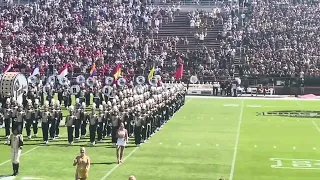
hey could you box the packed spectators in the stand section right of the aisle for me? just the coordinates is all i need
[240,1,320,77]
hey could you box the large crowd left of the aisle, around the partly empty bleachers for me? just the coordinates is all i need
[0,0,240,82]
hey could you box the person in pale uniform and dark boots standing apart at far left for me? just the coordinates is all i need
[9,128,23,176]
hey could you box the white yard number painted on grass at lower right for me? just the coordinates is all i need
[270,158,320,170]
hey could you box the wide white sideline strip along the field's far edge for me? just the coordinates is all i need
[187,95,320,100]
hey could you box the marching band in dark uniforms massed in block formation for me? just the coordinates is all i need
[2,81,185,146]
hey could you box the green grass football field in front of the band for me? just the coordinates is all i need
[0,97,320,180]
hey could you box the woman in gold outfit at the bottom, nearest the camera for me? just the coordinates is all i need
[73,147,90,180]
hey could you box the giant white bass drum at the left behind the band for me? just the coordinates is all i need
[0,72,28,104]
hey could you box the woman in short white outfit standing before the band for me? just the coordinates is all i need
[117,122,129,164]
